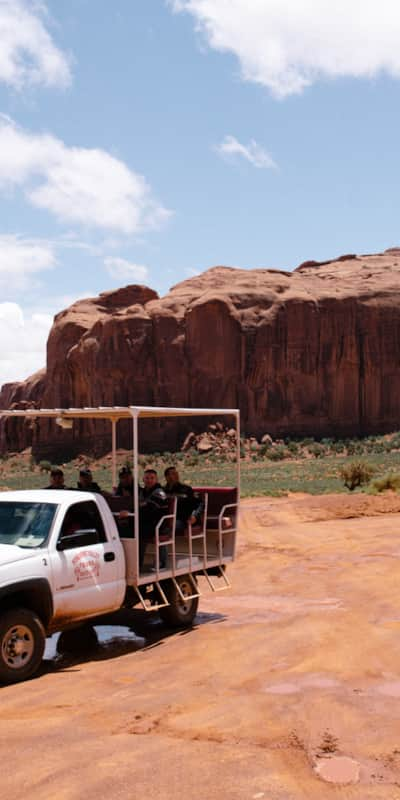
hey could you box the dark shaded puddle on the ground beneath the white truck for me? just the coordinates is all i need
[43,625,146,661]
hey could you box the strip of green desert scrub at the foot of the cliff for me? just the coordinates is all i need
[0,426,400,497]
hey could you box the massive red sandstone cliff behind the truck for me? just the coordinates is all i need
[0,255,400,456]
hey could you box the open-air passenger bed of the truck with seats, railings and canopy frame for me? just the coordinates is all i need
[0,406,240,610]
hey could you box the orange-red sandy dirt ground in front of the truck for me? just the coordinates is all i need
[0,495,400,800]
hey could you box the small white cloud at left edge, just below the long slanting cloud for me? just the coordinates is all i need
[0,235,56,290]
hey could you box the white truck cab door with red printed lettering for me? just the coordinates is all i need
[49,500,120,618]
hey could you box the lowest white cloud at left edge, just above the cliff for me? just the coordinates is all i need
[0,303,53,386]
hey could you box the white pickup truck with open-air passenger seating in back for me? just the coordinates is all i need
[0,408,238,683]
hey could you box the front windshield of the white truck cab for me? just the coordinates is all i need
[0,501,57,547]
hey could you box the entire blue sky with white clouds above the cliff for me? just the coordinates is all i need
[0,0,400,384]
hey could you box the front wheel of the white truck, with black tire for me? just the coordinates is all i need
[0,608,46,683]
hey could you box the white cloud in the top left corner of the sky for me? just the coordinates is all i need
[0,0,71,89]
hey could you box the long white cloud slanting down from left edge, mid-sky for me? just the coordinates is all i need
[0,115,170,234]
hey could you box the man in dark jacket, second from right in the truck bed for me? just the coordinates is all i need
[139,469,168,569]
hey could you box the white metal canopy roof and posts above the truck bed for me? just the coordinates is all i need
[0,406,240,556]
